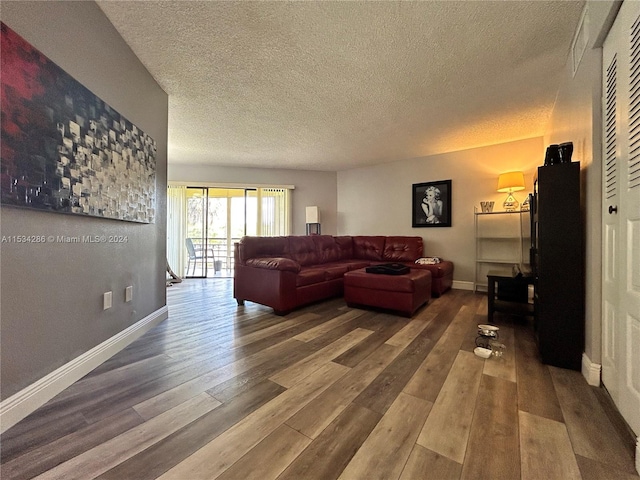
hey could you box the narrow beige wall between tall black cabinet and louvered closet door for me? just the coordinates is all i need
[544,1,619,364]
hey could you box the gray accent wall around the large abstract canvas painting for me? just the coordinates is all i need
[0,0,168,400]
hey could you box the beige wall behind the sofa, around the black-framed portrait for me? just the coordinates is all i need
[338,137,544,282]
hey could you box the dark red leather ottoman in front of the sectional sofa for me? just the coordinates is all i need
[343,268,431,317]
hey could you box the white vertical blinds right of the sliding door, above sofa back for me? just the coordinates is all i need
[258,188,291,237]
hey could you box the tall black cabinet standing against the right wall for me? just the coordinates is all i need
[531,162,585,370]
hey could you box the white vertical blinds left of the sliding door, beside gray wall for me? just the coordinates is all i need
[167,184,187,277]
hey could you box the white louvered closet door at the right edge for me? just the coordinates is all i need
[602,1,640,436]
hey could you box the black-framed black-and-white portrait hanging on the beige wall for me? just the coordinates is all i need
[411,180,451,228]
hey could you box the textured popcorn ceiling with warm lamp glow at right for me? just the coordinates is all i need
[98,0,584,170]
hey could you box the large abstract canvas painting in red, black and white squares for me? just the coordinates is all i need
[0,23,156,223]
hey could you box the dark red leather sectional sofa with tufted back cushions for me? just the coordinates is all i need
[233,235,453,315]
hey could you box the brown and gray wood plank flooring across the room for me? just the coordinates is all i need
[0,279,639,480]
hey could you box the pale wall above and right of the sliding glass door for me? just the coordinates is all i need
[168,164,337,235]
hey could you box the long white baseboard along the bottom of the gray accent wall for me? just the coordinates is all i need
[0,305,169,433]
